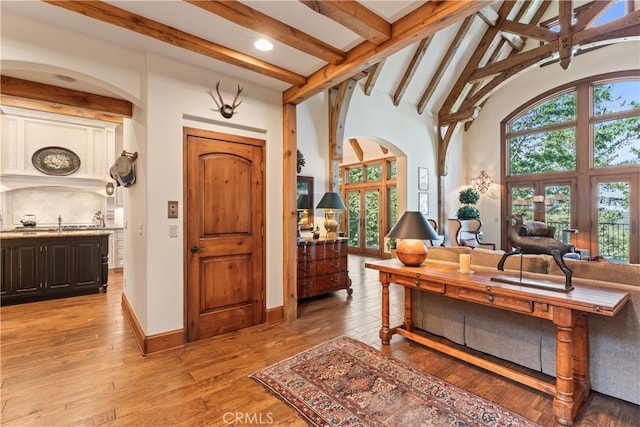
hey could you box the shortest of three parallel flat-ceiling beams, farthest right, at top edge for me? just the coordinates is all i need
[300,0,391,45]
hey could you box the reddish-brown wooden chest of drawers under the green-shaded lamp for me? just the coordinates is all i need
[297,239,353,299]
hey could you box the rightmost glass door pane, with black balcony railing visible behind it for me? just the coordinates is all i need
[591,175,640,263]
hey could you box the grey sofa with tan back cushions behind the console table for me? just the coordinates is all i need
[412,247,640,404]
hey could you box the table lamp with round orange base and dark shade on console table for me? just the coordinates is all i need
[387,211,439,267]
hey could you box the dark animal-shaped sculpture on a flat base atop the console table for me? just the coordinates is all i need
[494,215,575,292]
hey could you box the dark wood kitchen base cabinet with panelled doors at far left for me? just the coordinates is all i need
[0,233,109,305]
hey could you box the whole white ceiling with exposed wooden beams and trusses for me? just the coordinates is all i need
[1,0,640,155]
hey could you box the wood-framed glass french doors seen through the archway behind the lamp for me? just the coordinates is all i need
[346,187,382,257]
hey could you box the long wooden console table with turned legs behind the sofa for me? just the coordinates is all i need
[365,259,629,425]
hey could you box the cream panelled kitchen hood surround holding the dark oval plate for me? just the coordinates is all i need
[0,106,118,190]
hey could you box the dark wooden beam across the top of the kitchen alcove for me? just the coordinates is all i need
[0,76,133,119]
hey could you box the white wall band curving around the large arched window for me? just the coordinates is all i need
[464,42,640,249]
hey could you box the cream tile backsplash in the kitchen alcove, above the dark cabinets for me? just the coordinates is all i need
[0,187,106,230]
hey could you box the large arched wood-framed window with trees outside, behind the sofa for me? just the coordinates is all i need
[502,70,640,263]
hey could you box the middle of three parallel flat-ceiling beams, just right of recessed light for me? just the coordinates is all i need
[183,0,345,64]
